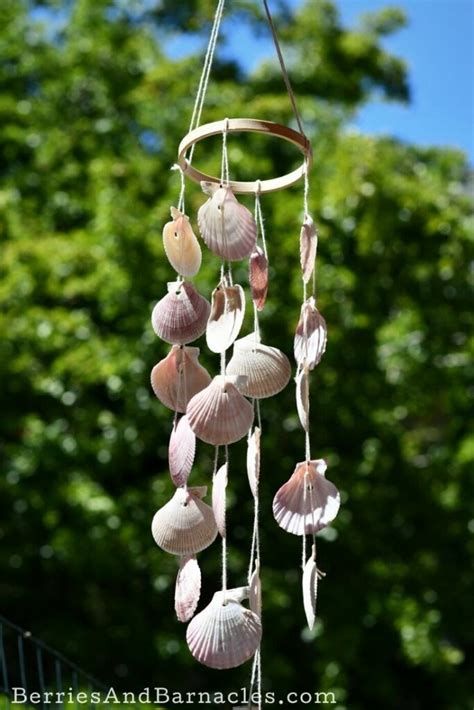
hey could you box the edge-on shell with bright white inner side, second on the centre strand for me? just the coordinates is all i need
[206,284,245,353]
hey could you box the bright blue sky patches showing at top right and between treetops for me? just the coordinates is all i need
[170,0,474,163]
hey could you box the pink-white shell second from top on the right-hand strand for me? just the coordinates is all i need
[294,296,327,370]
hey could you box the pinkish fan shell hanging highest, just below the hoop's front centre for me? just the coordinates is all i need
[198,183,257,261]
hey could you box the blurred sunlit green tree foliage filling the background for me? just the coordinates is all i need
[0,0,474,710]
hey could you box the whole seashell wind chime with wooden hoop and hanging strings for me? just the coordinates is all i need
[151,0,340,696]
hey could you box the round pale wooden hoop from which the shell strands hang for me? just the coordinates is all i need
[178,118,313,195]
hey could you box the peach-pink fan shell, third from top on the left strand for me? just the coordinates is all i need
[151,345,211,412]
